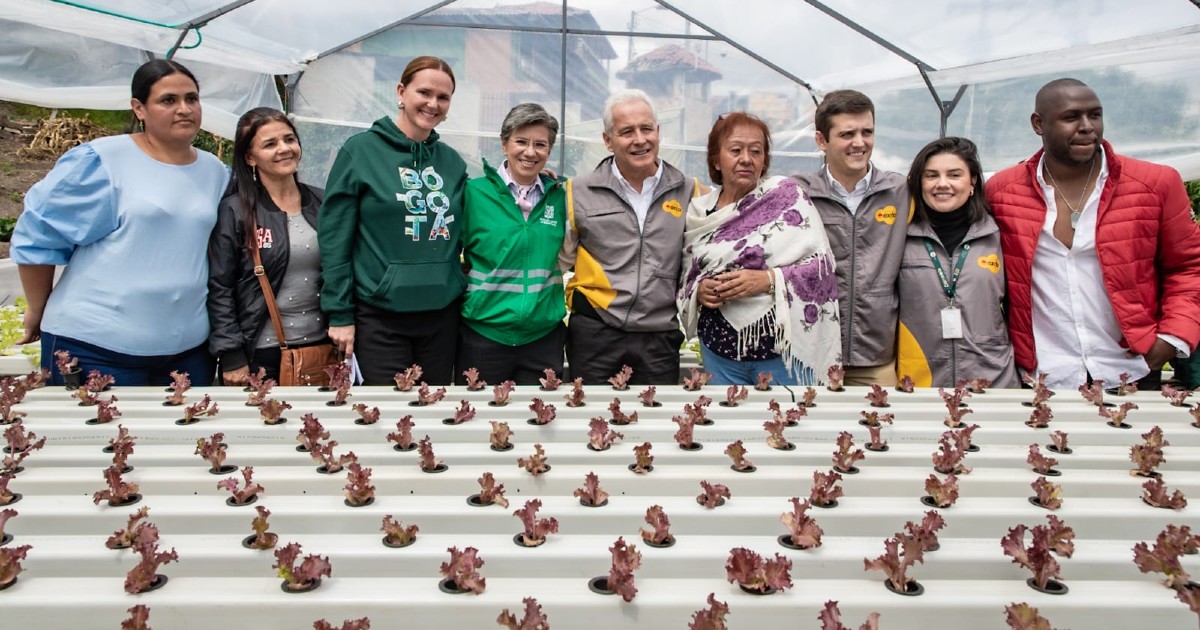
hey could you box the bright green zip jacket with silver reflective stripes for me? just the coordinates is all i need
[461,161,566,346]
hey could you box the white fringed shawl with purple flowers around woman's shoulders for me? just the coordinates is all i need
[679,176,841,385]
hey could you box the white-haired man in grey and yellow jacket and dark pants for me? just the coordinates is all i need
[559,90,698,385]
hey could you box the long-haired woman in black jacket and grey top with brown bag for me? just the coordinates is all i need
[208,107,328,385]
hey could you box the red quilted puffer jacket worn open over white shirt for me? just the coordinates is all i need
[986,142,1200,372]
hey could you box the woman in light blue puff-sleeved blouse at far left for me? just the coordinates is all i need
[11,59,229,385]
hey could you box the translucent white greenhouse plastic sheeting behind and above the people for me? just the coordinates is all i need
[0,0,1200,184]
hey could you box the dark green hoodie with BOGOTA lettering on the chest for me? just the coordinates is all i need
[317,118,467,326]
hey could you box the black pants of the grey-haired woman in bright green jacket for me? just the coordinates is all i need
[455,324,566,385]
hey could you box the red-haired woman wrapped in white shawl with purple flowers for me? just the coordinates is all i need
[679,112,841,385]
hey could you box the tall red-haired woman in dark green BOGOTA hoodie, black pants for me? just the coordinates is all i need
[317,56,467,385]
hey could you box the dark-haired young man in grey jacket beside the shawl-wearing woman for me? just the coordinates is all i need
[796,90,911,385]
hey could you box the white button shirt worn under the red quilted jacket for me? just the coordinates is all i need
[1032,150,1150,389]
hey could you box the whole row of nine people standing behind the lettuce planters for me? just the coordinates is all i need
[12,56,1200,386]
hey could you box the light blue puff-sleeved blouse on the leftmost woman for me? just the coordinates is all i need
[11,136,229,356]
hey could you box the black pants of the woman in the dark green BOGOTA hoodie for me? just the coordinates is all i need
[354,300,462,385]
